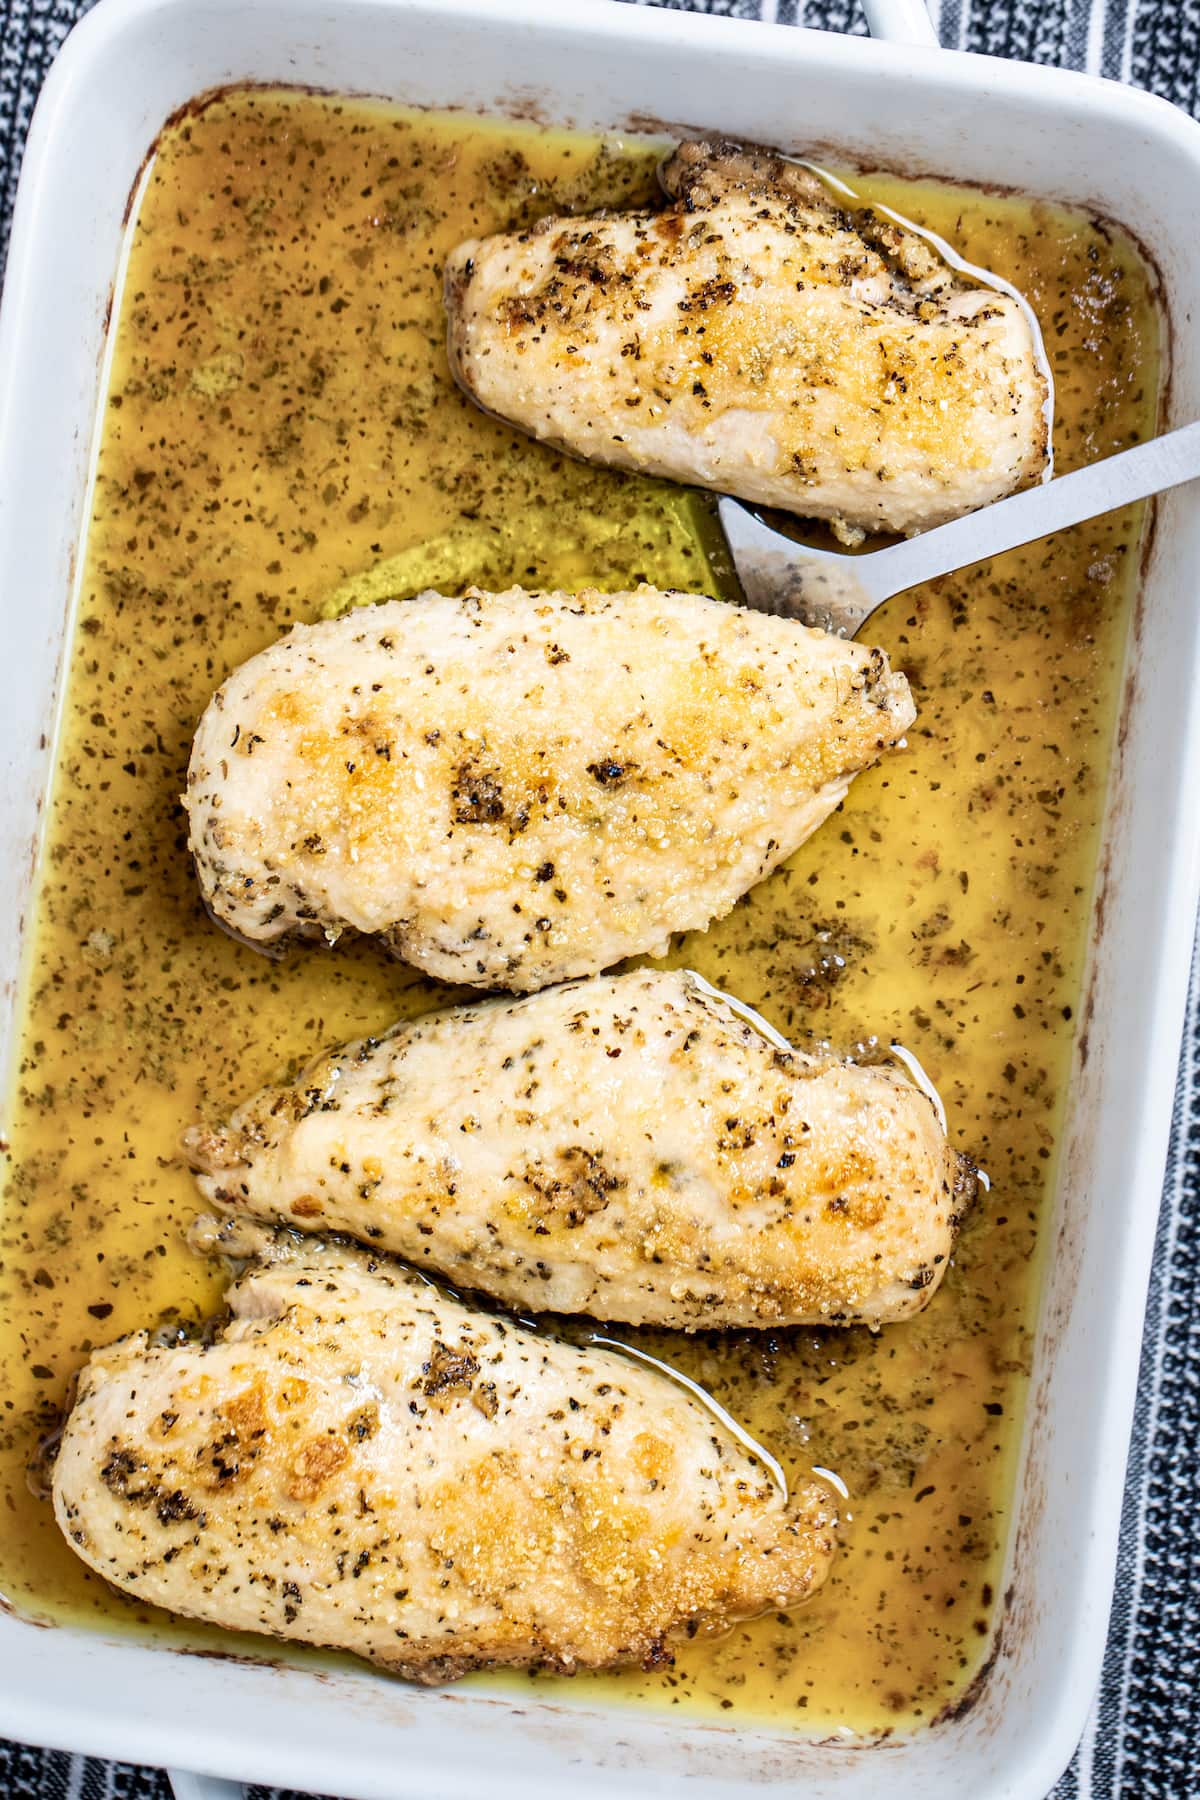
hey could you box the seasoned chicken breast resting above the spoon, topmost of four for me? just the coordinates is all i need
[446,142,1047,533]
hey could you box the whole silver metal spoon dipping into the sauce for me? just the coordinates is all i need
[718,421,1200,637]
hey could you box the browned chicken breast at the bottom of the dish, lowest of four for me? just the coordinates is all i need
[54,1244,837,1681]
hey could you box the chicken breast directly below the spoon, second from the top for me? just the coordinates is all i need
[185,587,914,990]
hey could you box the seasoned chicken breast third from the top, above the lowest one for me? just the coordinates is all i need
[185,968,973,1330]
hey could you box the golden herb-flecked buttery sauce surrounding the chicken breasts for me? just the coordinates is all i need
[0,92,1159,1733]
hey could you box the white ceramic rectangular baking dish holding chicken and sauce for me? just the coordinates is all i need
[0,0,1200,1800]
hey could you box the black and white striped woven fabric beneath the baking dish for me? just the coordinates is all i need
[0,0,1200,1800]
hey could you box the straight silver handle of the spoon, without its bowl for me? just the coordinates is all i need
[856,421,1200,598]
